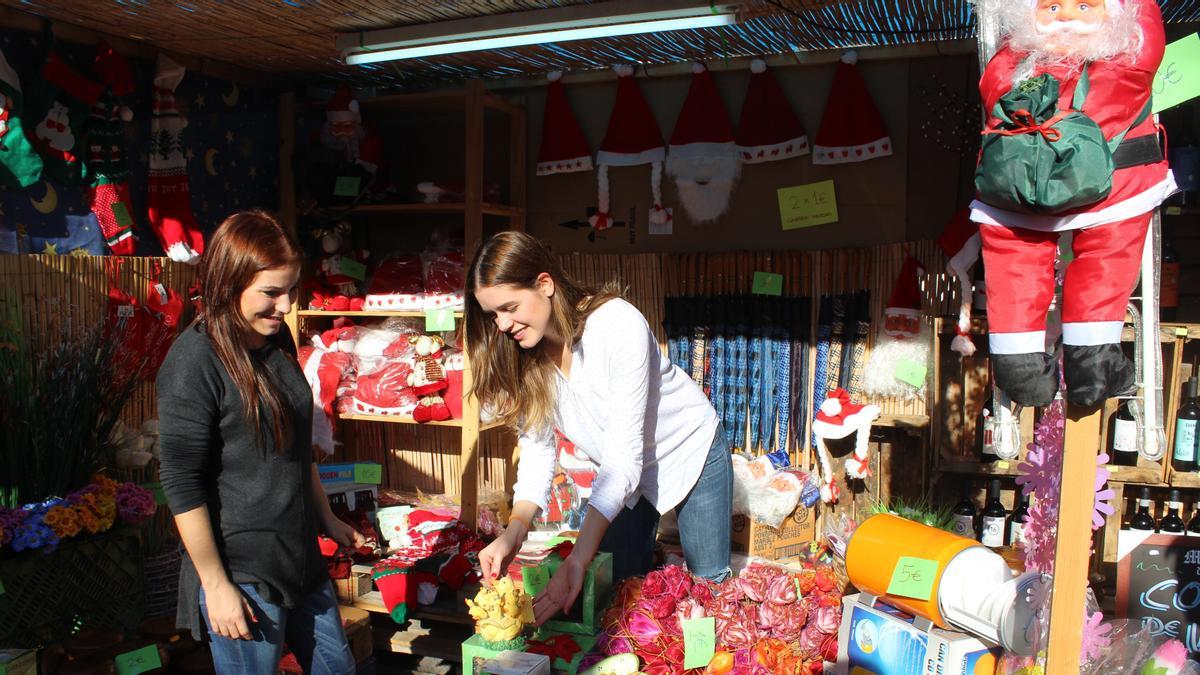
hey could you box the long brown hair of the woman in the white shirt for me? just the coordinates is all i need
[463,232,620,431]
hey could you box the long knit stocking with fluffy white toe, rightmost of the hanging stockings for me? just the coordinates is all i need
[146,54,204,264]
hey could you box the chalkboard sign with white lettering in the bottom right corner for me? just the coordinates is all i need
[1117,534,1200,658]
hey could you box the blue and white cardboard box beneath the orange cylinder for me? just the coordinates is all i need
[834,593,1003,675]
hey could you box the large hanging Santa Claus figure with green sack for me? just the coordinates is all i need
[971,0,1175,406]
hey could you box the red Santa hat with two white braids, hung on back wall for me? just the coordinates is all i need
[588,66,671,229]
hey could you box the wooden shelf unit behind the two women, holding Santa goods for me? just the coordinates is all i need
[281,80,526,530]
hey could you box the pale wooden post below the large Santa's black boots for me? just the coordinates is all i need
[1046,405,1100,673]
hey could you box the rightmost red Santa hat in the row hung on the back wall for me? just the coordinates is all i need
[812,50,892,165]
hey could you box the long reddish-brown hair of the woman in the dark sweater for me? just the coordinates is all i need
[197,209,304,454]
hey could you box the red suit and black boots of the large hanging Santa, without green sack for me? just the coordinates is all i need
[971,0,1175,406]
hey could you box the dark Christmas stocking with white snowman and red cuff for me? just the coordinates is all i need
[30,52,104,185]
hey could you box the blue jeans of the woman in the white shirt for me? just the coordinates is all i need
[600,426,733,583]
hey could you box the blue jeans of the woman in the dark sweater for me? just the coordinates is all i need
[200,581,355,675]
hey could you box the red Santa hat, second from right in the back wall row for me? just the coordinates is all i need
[736,59,809,165]
